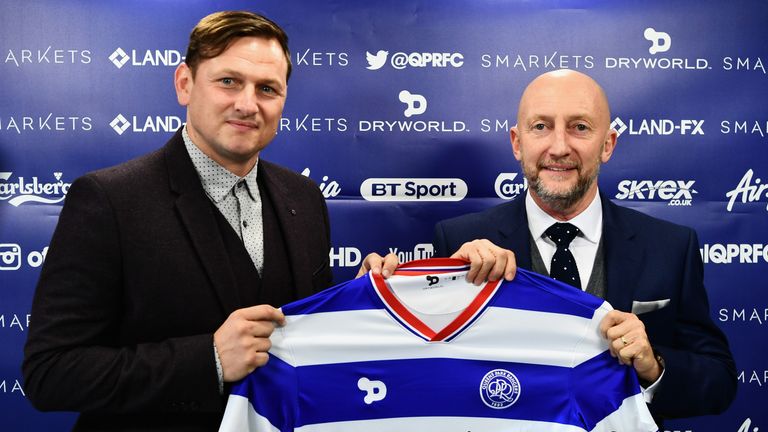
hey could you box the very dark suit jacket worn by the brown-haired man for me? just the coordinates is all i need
[23,132,331,431]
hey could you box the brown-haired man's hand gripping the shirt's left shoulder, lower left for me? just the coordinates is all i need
[213,305,285,382]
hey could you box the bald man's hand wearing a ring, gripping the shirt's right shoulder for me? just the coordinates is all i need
[600,310,662,384]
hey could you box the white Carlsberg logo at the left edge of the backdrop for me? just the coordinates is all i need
[0,172,71,207]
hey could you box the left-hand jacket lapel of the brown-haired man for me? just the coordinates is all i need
[163,129,241,314]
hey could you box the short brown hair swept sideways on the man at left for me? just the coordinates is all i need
[185,11,291,81]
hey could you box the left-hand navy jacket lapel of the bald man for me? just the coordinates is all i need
[488,195,531,270]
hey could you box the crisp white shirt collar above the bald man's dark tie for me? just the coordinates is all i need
[525,191,603,244]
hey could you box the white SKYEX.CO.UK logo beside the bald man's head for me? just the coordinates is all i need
[616,180,698,206]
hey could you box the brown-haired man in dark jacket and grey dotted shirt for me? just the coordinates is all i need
[23,12,331,431]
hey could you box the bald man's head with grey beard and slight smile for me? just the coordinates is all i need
[510,70,616,219]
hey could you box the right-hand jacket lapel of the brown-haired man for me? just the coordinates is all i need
[259,159,317,298]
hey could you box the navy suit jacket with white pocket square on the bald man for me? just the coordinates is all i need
[433,195,736,418]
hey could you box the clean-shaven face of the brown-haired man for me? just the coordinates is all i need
[175,36,288,176]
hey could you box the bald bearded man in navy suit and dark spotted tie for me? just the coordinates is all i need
[363,70,736,422]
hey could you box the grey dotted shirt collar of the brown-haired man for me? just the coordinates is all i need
[181,125,259,204]
